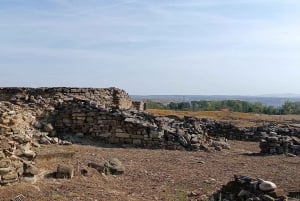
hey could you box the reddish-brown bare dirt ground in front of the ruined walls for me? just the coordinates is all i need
[0,141,300,201]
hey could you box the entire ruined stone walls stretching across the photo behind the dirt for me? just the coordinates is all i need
[0,87,300,188]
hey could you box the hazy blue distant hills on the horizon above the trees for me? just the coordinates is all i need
[131,94,300,107]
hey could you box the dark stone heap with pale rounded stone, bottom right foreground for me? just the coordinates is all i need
[213,176,290,201]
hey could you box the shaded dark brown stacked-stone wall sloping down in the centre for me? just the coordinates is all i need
[54,100,213,150]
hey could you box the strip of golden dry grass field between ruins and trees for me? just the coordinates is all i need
[147,109,300,127]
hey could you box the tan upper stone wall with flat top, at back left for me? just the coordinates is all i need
[0,87,132,109]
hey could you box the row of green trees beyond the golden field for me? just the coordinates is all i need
[146,100,300,115]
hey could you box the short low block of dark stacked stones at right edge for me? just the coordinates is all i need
[260,132,300,155]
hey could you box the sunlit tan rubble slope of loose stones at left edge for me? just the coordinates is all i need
[0,101,72,186]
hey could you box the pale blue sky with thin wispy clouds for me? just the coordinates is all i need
[0,0,300,95]
